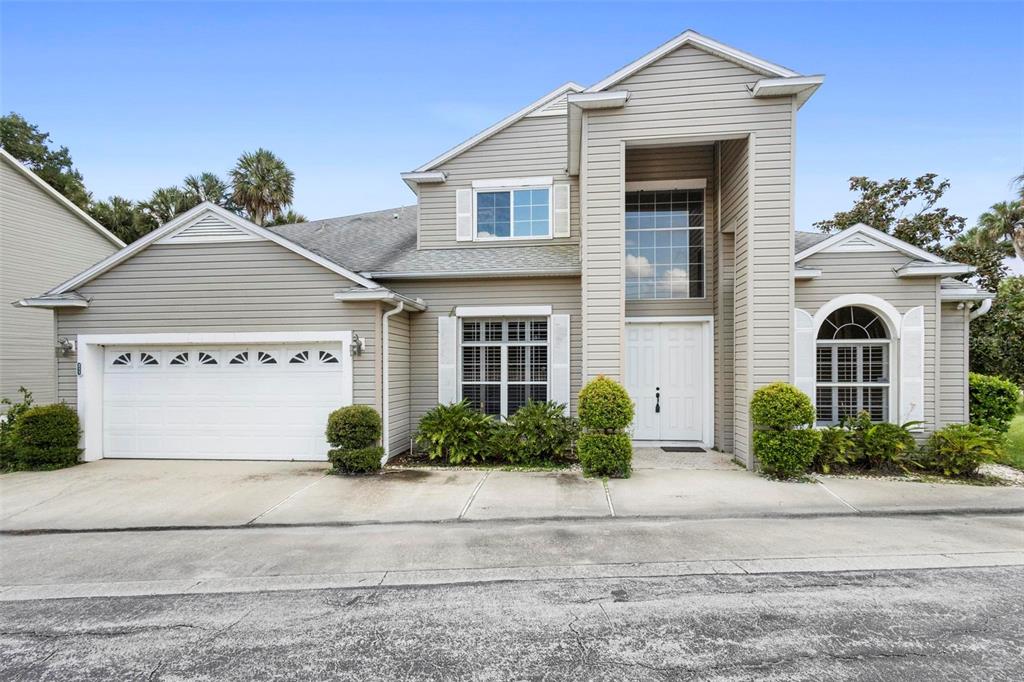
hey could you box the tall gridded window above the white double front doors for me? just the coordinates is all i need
[626,189,705,300]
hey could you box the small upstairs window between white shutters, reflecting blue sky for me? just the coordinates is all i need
[475,187,551,240]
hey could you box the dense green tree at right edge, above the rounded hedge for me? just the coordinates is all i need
[971,275,1024,386]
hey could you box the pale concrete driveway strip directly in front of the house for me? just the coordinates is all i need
[0,451,1024,531]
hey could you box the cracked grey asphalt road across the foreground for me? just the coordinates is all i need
[0,557,1024,681]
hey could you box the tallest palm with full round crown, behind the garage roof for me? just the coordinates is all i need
[230,147,295,225]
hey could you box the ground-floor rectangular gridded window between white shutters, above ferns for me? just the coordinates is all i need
[459,319,548,417]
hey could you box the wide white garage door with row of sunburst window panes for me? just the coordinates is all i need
[103,343,346,460]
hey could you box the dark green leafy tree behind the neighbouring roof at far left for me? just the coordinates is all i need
[0,112,91,209]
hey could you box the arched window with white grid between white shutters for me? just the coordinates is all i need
[815,305,891,425]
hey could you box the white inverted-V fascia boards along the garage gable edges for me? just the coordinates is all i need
[46,202,380,296]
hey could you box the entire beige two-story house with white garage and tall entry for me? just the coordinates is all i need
[18,32,990,466]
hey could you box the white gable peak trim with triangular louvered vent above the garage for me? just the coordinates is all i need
[46,202,380,296]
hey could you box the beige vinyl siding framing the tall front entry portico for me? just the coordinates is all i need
[583,46,795,460]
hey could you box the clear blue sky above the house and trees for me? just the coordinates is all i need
[6,2,1024,227]
